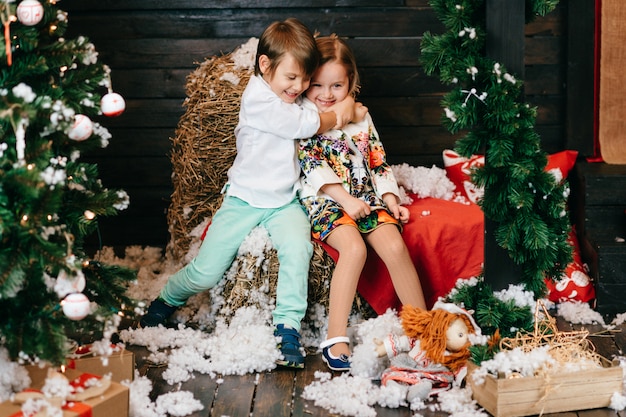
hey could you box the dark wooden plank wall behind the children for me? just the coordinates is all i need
[60,0,586,250]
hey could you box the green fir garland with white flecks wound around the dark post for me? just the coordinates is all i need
[421,0,572,363]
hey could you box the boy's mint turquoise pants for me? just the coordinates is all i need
[160,196,313,330]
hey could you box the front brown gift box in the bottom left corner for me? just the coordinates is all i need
[0,369,130,417]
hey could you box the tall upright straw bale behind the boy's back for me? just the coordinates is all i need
[167,54,252,259]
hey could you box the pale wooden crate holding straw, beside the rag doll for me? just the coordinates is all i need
[466,360,622,417]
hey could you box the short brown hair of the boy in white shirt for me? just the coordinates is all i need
[254,17,319,77]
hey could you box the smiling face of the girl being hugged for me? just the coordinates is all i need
[306,61,350,112]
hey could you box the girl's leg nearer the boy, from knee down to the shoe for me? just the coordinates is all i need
[326,225,367,357]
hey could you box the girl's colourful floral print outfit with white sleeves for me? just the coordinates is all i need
[298,100,400,240]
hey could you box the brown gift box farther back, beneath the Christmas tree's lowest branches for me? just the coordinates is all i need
[26,345,135,382]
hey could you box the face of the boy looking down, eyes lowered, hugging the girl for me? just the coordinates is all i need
[259,54,311,103]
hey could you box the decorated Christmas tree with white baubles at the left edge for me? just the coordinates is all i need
[0,0,135,365]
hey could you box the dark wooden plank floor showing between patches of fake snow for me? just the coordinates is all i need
[127,318,626,417]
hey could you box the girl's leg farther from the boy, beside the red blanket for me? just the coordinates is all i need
[364,224,426,309]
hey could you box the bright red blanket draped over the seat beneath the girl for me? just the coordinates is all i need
[322,198,484,314]
